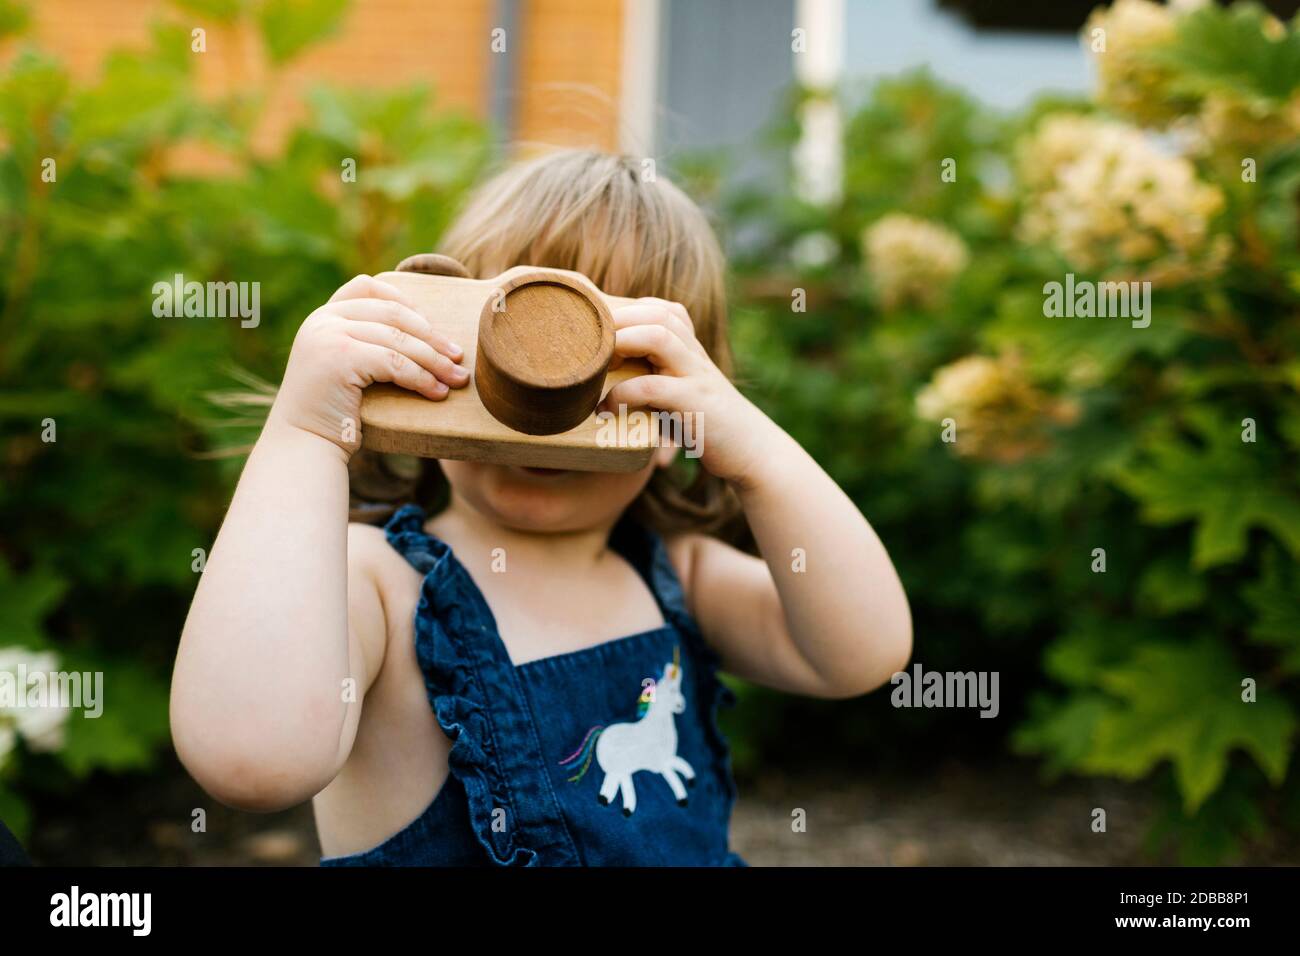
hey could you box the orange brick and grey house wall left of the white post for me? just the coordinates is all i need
[15,0,793,168]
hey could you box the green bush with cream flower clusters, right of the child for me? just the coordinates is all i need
[732,0,1300,861]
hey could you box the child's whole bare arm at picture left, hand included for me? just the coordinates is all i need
[172,277,468,810]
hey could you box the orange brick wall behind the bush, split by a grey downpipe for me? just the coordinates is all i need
[15,0,623,155]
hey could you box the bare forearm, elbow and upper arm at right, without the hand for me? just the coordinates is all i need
[671,432,911,697]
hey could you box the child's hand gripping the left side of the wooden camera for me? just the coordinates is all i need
[270,276,469,454]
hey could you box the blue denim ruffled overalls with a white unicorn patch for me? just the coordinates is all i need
[321,505,745,866]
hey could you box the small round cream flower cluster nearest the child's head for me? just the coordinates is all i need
[862,212,970,310]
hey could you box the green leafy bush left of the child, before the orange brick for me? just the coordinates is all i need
[0,3,488,831]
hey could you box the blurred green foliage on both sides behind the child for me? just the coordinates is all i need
[0,0,1300,862]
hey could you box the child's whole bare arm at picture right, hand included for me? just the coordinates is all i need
[605,299,911,697]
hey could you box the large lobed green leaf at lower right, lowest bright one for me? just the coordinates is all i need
[1080,637,1296,813]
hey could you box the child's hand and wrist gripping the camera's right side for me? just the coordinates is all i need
[601,298,779,486]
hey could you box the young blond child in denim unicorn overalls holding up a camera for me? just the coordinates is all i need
[172,151,911,865]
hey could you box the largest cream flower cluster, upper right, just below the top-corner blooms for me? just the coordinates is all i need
[1018,114,1229,285]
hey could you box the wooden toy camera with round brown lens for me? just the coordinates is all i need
[361,254,653,471]
